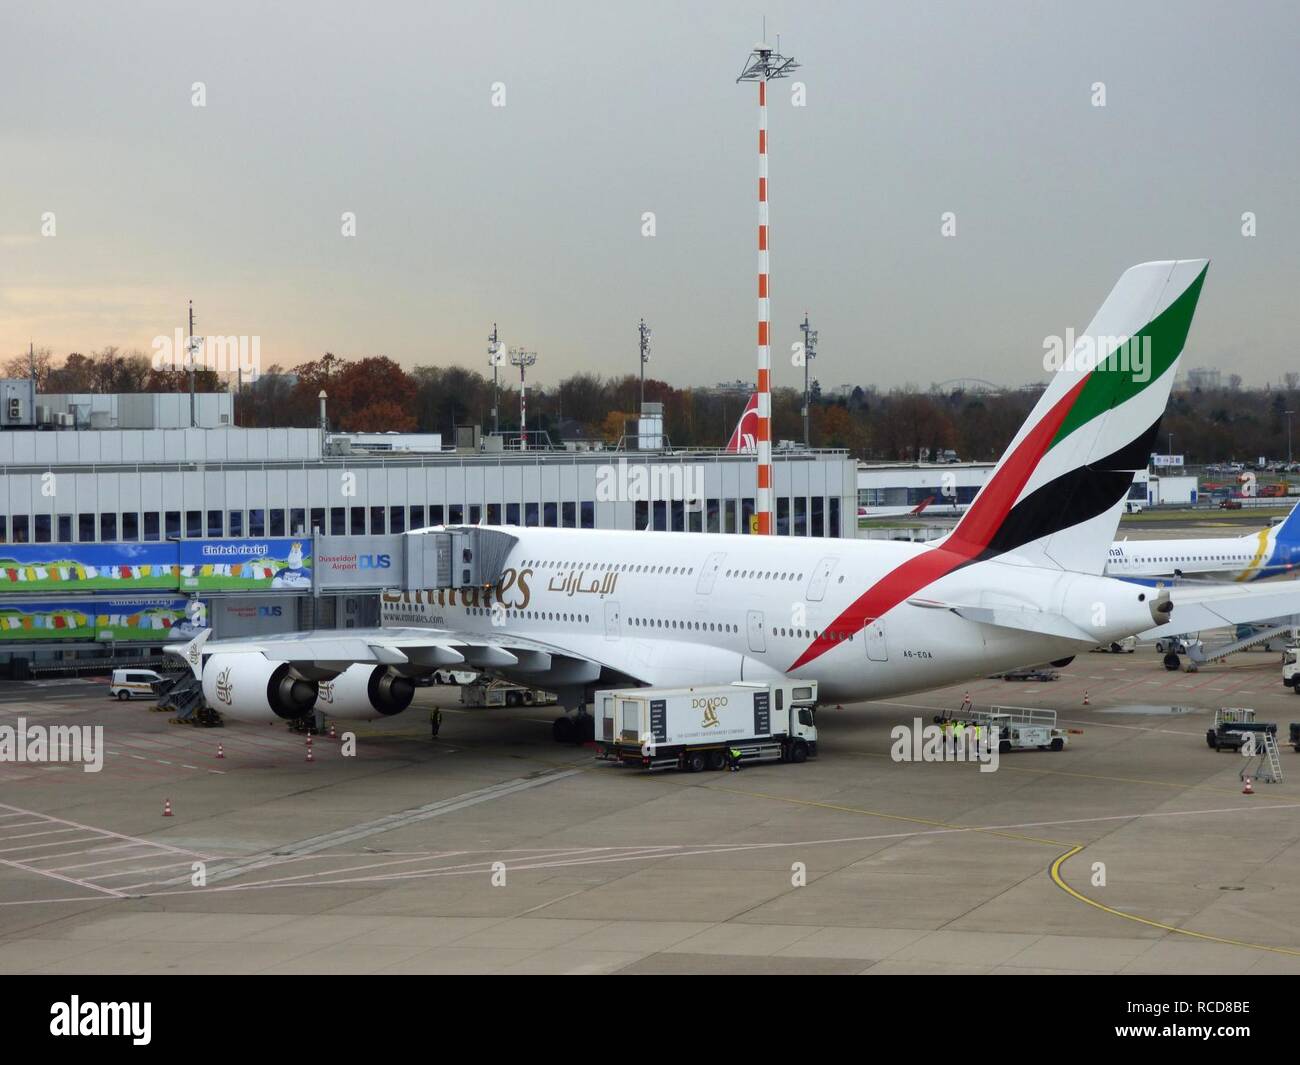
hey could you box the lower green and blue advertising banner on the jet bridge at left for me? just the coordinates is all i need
[0,597,198,646]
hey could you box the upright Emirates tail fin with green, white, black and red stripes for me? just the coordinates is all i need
[943,259,1209,573]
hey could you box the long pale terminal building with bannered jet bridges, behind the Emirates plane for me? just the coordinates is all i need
[0,408,857,676]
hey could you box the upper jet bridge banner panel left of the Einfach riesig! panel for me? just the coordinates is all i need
[0,544,181,594]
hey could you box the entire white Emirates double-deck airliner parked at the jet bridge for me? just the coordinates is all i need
[177,260,1206,739]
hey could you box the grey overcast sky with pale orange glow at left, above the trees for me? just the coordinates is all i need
[0,0,1300,386]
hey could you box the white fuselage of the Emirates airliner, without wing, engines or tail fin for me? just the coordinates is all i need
[382,528,1151,700]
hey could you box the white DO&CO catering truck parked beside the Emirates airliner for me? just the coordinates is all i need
[594,680,816,772]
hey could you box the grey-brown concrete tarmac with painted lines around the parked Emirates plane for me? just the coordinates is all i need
[0,649,1300,974]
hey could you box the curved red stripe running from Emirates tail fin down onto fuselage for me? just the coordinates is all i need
[785,376,1088,674]
